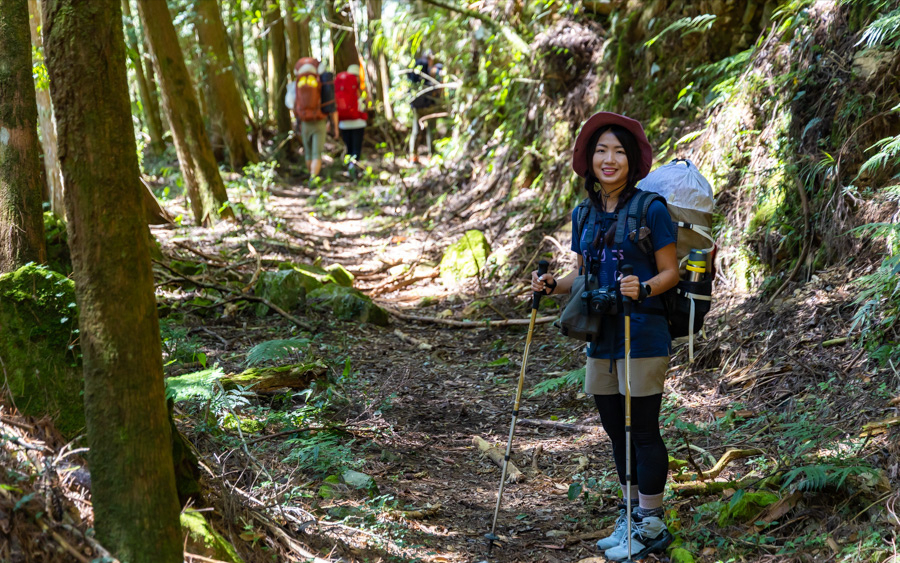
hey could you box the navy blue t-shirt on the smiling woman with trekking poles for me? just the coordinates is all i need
[572,196,675,360]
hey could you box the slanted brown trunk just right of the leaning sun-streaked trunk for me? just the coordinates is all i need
[194,0,259,171]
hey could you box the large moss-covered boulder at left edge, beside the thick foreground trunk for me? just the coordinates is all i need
[0,264,84,438]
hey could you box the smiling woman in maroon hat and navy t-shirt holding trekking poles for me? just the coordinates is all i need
[531,112,678,561]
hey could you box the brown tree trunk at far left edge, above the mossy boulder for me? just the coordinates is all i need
[0,0,47,273]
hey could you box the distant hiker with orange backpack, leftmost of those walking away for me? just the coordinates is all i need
[285,57,337,184]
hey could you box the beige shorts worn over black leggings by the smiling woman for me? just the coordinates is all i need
[584,356,669,397]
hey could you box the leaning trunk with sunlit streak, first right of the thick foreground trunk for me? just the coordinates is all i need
[138,0,234,224]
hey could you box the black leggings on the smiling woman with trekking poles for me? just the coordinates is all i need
[594,394,669,495]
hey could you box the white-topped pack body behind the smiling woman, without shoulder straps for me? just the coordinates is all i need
[638,159,716,361]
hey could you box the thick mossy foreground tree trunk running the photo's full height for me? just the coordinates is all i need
[44,0,184,563]
